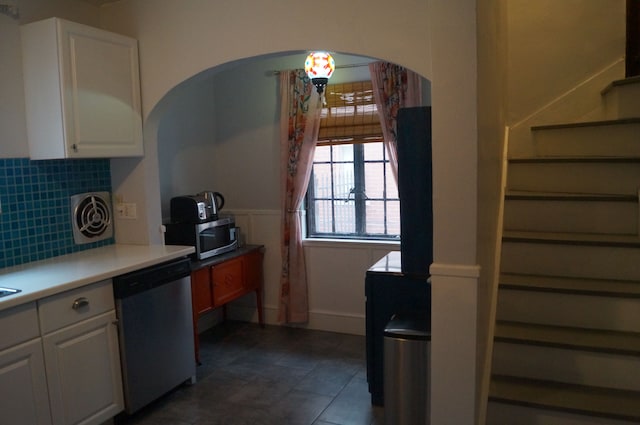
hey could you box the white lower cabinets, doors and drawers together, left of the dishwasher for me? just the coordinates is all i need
[0,280,124,425]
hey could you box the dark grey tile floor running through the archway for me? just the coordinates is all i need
[116,322,384,425]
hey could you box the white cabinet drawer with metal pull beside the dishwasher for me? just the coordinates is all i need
[38,279,114,334]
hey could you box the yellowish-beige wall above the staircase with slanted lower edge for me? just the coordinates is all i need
[506,0,625,125]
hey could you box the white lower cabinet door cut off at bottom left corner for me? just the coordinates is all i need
[0,338,51,425]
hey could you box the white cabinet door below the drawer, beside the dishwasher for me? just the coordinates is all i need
[43,311,124,425]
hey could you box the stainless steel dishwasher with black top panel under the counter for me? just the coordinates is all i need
[113,258,196,414]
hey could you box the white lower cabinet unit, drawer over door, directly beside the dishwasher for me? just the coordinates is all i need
[38,280,124,425]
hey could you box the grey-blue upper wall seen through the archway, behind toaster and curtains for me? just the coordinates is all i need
[148,51,430,221]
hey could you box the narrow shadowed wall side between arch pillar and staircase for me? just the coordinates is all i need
[477,0,508,418]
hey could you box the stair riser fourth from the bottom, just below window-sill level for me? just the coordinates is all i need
[501,242,640,280]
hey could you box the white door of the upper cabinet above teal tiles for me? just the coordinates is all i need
[60,21,142,158]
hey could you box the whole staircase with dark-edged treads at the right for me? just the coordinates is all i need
[486,79,640,425]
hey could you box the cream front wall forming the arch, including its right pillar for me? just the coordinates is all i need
[101,0,478,424]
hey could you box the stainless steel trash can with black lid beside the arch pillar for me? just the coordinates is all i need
[384,313,431,425]
